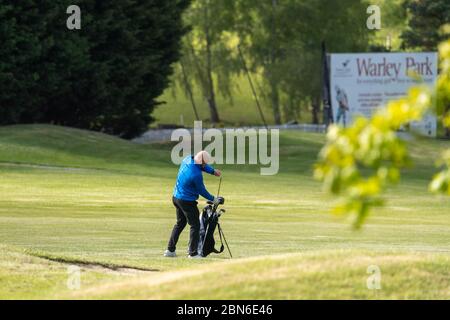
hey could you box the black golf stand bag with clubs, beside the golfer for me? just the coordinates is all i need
[198,201,233,257]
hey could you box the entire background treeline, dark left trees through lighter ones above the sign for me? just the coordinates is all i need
[0,0,450,138]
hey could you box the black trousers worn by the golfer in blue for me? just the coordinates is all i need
[167,197,200,256]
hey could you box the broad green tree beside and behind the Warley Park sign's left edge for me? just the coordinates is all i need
[236,0,368,123]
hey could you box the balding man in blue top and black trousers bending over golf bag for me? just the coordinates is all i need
[164,151,224,259]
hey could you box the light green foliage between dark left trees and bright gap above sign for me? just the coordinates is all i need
[170,0,369,123]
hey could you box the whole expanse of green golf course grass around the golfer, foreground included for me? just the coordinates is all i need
[0,125,450,299]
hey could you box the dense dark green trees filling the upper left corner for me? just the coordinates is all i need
[0,0,189,137]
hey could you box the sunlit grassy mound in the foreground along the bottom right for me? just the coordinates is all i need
[68,250,450,300]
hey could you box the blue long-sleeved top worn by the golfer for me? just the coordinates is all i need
[173,156,214,201]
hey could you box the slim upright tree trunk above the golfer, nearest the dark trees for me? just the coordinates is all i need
[205,1,220,124]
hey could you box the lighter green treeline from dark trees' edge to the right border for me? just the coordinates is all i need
[176,0,450,124]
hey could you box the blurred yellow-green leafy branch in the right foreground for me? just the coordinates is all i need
[314,40,450,228]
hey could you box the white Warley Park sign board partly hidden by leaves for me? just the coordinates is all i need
[330,52,438,137]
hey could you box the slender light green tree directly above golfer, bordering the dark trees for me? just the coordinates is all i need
[178,0,238,124]
